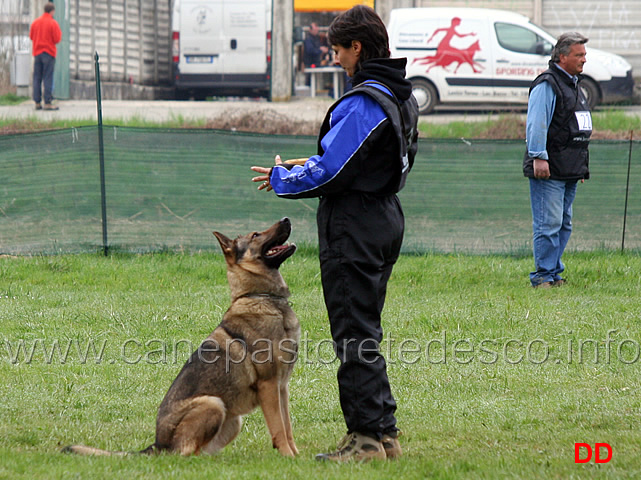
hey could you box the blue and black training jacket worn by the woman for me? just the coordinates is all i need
[270,81,418,198]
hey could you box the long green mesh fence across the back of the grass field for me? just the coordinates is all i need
[0,126,641,255]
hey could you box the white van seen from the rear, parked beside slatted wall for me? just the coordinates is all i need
[172,0,272,98]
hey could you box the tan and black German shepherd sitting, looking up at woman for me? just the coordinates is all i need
[63,218,300,457]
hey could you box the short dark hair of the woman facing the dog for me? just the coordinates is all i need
[327,5,390,63]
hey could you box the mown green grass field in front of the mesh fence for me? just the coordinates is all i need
[0,249,641,479]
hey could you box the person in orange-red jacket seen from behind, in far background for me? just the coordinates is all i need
[29,2,62,110]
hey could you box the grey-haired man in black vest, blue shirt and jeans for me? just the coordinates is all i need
[523,32,592,288]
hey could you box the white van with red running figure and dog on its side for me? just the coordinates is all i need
[388,8,634,114]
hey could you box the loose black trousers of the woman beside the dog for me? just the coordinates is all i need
[317,193,404,438]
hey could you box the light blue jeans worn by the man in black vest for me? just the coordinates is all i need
[530,178,577,286]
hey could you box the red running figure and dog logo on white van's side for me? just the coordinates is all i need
[412,17,483,73]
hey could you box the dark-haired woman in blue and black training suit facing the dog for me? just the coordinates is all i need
[252,5,418,461]
